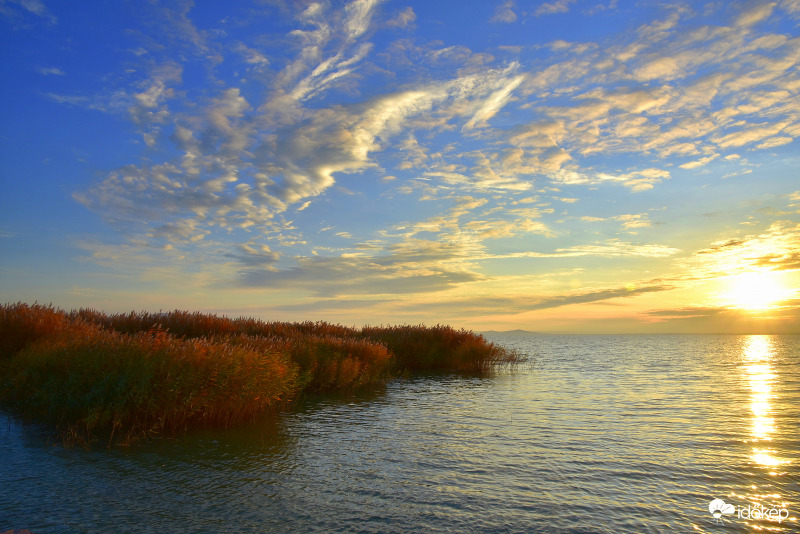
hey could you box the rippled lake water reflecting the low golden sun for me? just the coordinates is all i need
[0,334,800,534]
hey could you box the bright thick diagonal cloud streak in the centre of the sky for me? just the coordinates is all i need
[262,62,536,204]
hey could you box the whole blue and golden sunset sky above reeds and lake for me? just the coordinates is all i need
[0,0,800,333]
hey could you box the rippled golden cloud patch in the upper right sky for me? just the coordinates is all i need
[488,2,800,186]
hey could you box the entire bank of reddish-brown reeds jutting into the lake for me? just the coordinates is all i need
[0,303,525,446]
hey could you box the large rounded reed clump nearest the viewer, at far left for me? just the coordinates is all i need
[0,324,300,443]
